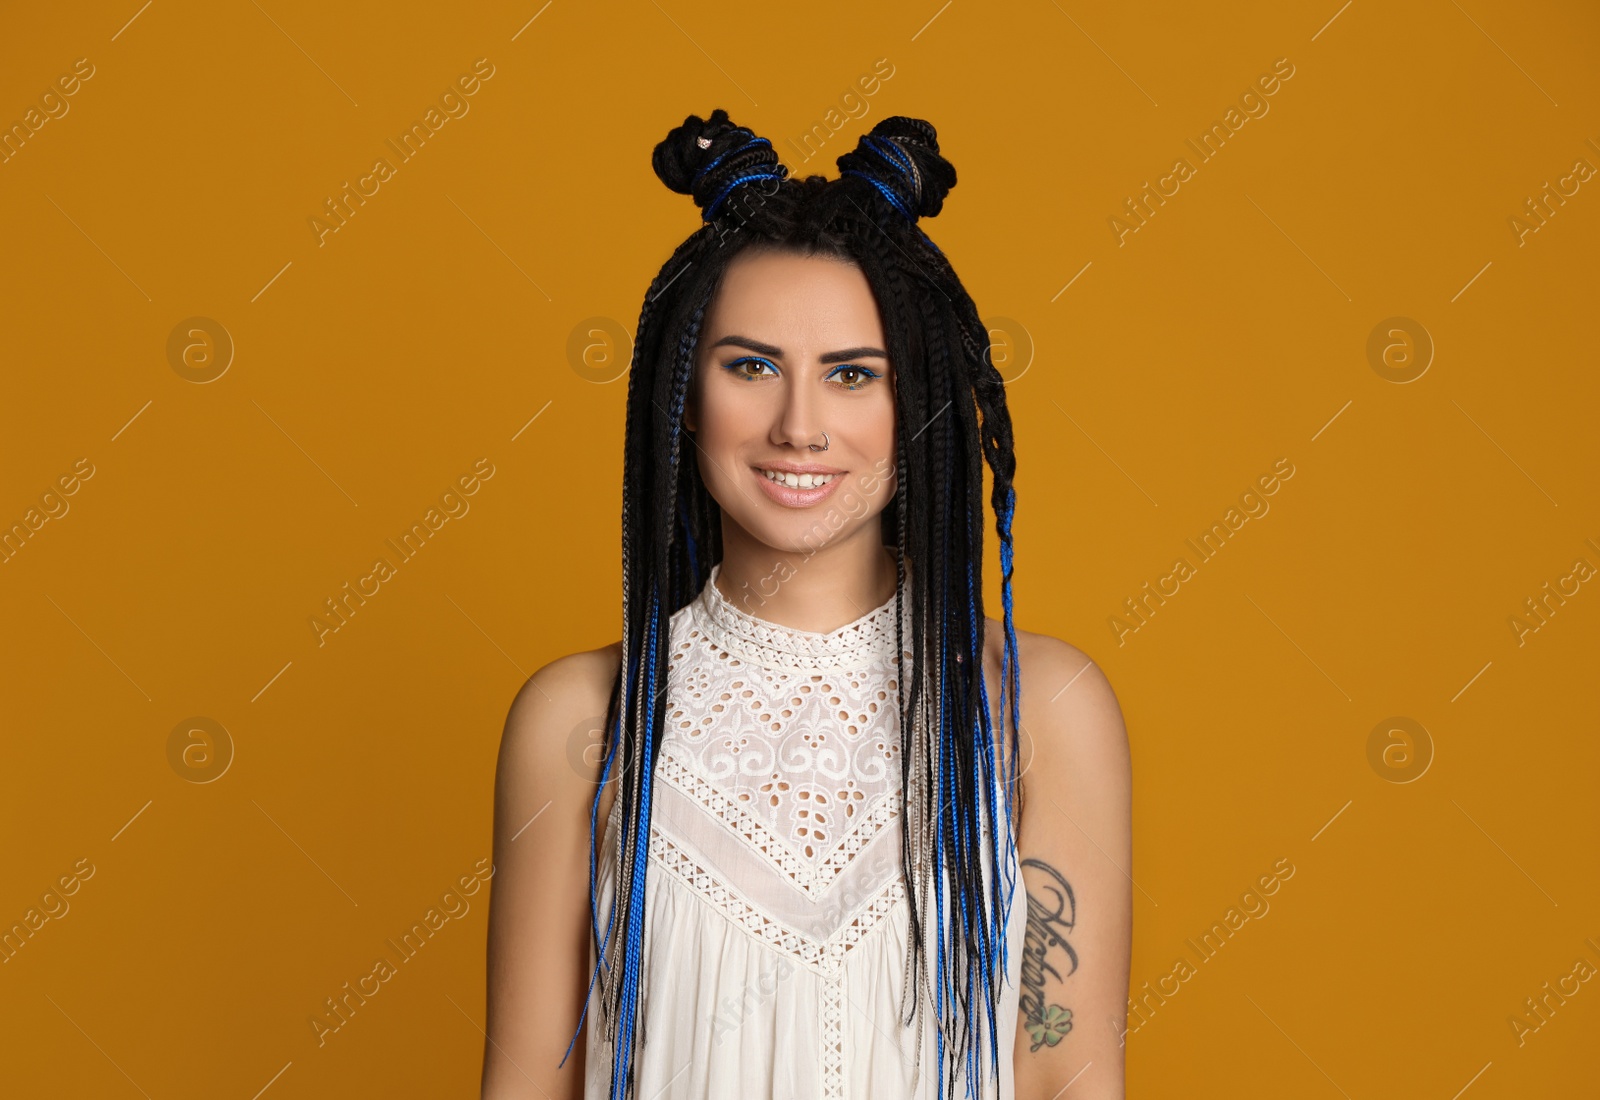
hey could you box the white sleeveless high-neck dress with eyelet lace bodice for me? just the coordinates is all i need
[584,564,1027,1100]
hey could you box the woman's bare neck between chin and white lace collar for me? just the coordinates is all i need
[715,528,896,633]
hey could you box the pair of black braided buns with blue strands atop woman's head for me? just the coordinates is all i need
[651,107,955,224]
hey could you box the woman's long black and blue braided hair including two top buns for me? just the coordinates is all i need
[568,109,1021,1100]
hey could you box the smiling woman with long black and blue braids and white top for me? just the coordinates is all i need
[483,110,1131,1100]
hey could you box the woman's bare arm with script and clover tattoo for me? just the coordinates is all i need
[1014,632,1133,1100]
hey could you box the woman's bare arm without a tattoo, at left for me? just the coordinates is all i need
[482,646,621,1100]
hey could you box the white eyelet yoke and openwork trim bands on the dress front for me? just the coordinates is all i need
[650,566,912,1097]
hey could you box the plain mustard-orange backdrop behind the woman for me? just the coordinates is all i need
[0,0,1600,1100]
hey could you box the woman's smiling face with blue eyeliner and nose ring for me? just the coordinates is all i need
[683,251,896,553]
